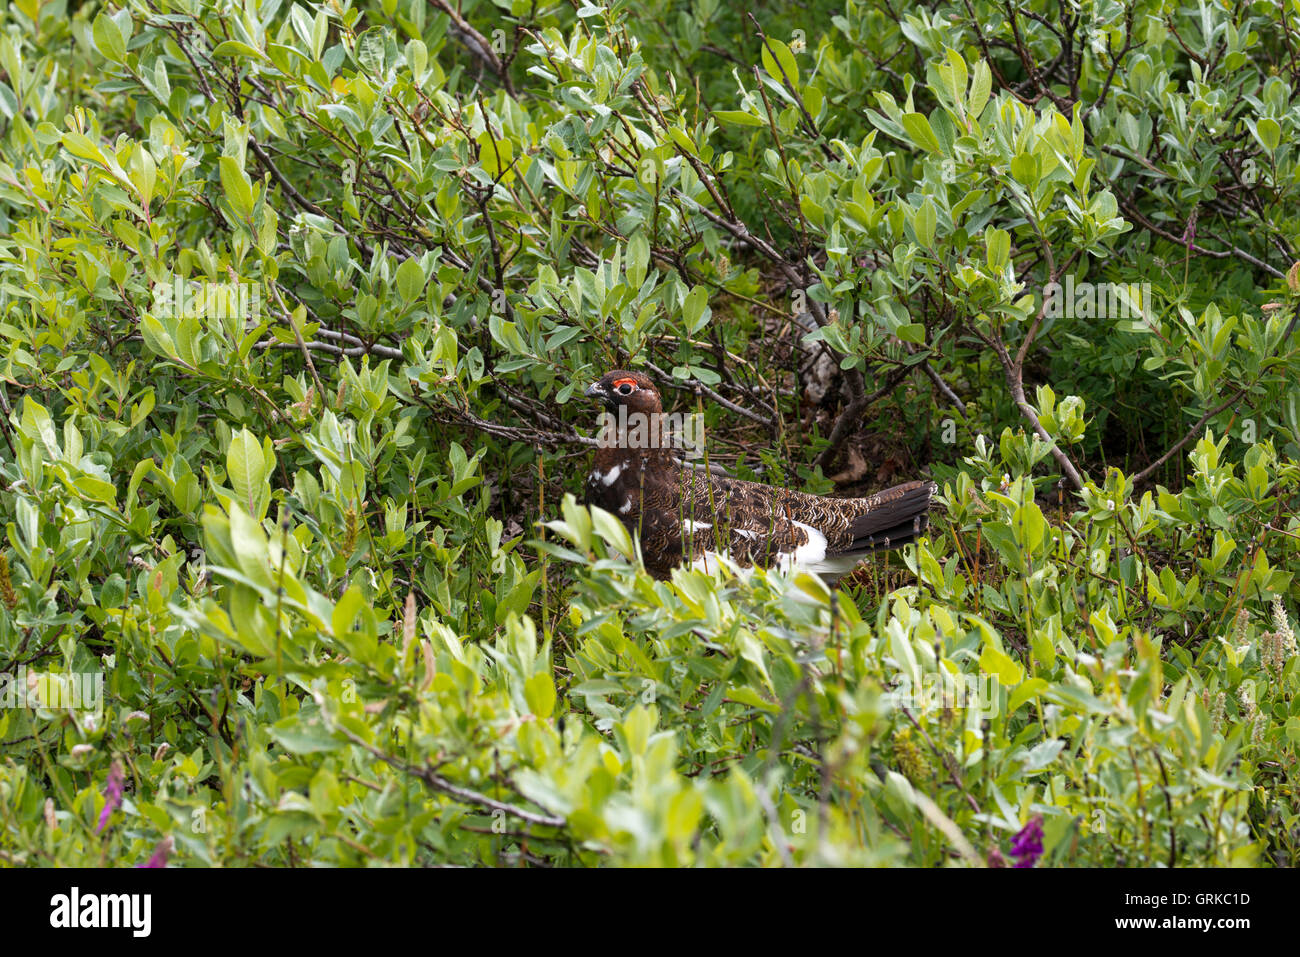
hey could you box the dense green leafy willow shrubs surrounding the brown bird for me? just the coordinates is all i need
[0,0,1300,866]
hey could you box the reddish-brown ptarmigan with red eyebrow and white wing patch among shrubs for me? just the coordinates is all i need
[585,369,936,584]
